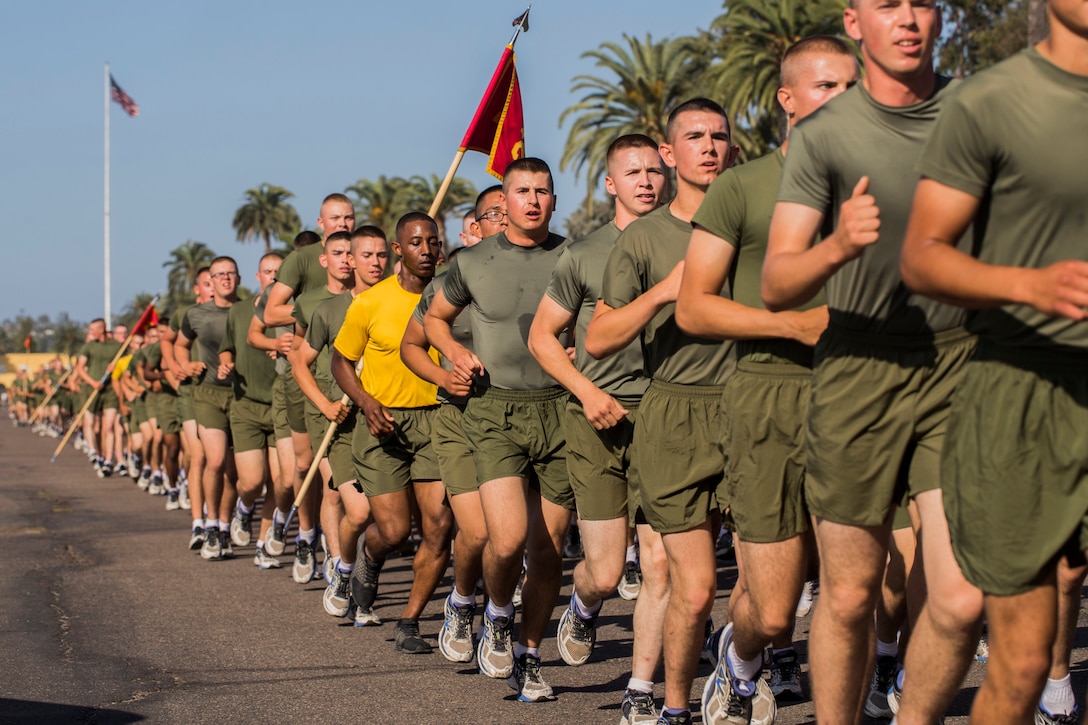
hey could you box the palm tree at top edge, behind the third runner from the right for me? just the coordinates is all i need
[700,0,846,158]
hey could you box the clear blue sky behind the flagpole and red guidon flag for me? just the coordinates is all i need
[0,0,721,320]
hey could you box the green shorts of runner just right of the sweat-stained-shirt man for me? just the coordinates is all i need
[562,396,639,521]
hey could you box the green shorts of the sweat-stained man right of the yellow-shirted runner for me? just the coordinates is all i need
[463,388,574,511]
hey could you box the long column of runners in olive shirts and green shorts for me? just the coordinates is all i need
[13,0,1088,725]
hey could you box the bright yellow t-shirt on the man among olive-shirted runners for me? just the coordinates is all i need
[333,277,438,408]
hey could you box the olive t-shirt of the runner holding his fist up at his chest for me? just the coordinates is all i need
[778,77,965,335]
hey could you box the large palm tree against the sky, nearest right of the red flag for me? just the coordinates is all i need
[559,34,704,205]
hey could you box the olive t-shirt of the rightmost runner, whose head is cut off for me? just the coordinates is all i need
[918,48,1088,348]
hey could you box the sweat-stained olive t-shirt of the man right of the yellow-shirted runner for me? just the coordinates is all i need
[443,232,567,390]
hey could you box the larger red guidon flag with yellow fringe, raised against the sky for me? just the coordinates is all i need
[460,45,526,179]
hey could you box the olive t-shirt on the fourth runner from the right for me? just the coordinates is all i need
[601,205,735,385]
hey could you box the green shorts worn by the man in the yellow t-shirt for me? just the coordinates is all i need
[351,405,442,496]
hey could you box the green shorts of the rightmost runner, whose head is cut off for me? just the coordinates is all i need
[941,342,1088,595]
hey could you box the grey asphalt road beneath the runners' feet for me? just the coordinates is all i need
[0,422,1088,725]
